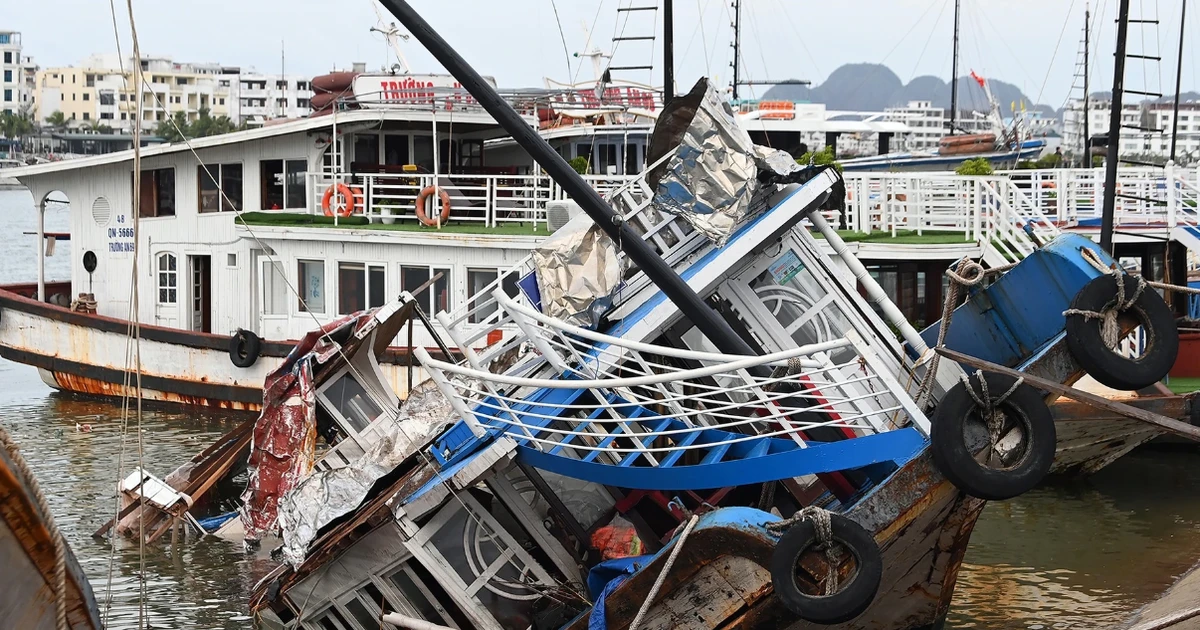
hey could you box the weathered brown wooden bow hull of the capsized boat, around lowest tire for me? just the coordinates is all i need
[569,450,985,630]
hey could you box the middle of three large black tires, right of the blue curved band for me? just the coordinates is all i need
[929,373,1058,500]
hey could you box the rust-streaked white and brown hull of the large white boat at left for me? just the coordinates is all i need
[0,289,425,413]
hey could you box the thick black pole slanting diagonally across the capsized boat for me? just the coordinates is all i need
[379,0,758,356]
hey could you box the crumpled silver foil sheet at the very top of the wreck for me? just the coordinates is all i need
[654,82,758,245]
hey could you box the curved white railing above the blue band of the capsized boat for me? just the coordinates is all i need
[416,292,929,456]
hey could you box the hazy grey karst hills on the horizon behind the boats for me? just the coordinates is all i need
[763,64,1055,115]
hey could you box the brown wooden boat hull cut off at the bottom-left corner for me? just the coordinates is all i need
[0,428,103,630]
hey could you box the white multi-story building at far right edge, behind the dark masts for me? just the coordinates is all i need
[1062,98,1200,164]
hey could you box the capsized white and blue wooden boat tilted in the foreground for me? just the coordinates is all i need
[243,79,1070,629]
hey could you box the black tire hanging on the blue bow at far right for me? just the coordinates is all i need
[1067,275,1180,391]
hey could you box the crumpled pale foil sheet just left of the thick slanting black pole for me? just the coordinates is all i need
[533,221,622,329]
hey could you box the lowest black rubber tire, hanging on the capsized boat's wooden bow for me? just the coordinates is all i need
[770,514,883,625]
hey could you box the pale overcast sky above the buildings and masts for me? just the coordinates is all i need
[9,0,1200,107]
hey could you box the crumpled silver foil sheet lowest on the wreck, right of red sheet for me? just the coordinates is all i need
[278,380,463,568]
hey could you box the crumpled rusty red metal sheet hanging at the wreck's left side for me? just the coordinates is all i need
[240,313,373,541]
